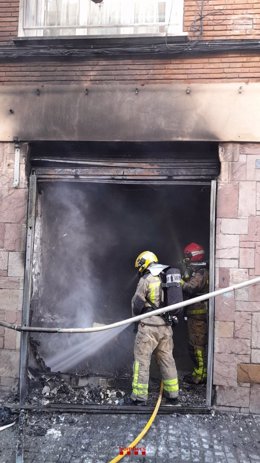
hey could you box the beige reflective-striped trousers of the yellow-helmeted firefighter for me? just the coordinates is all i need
[131,323,179,401]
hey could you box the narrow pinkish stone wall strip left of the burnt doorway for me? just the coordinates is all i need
[0,143,27,391]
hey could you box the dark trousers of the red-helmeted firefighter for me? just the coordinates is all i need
[188,314,208,383]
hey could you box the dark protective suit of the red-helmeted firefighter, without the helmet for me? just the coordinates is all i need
[182,264,209,383]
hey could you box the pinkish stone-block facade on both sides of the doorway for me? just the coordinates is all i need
[0,143,260,413]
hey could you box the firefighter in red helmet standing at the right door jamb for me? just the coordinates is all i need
[181,243,209,384]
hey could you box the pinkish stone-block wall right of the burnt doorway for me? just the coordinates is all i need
[214,144,260,413]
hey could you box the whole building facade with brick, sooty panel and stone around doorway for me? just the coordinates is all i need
[0,0,260,413]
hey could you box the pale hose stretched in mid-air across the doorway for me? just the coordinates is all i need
[0,277,260,333]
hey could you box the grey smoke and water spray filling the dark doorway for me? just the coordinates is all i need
[31,182,209,374]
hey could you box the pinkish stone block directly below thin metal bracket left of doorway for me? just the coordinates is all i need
[0,189,27,223]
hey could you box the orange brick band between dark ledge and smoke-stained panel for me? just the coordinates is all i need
[0,54,260,85]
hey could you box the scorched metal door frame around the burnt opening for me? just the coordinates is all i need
[19,169,217,406]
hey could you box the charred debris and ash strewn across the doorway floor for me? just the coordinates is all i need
[24,371,206,407]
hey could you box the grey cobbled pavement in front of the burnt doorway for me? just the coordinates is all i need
[0,409,260,463]
